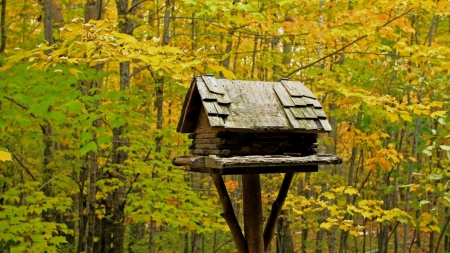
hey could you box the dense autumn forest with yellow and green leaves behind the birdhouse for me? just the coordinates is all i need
[0,0,450,253]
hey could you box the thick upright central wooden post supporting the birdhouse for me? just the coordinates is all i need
[242,174,264,253]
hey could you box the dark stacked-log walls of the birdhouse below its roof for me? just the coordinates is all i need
[189,128,317,156]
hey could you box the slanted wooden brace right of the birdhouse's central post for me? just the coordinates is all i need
[264,173,294,252]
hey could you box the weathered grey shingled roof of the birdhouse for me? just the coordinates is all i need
[177,75,332,133]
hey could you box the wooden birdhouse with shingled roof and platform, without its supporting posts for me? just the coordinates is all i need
[177,75,340,174]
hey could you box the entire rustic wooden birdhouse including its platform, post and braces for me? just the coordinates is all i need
[172,75,342,253]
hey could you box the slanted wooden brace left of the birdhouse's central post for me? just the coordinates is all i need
[211,174,250,253]
